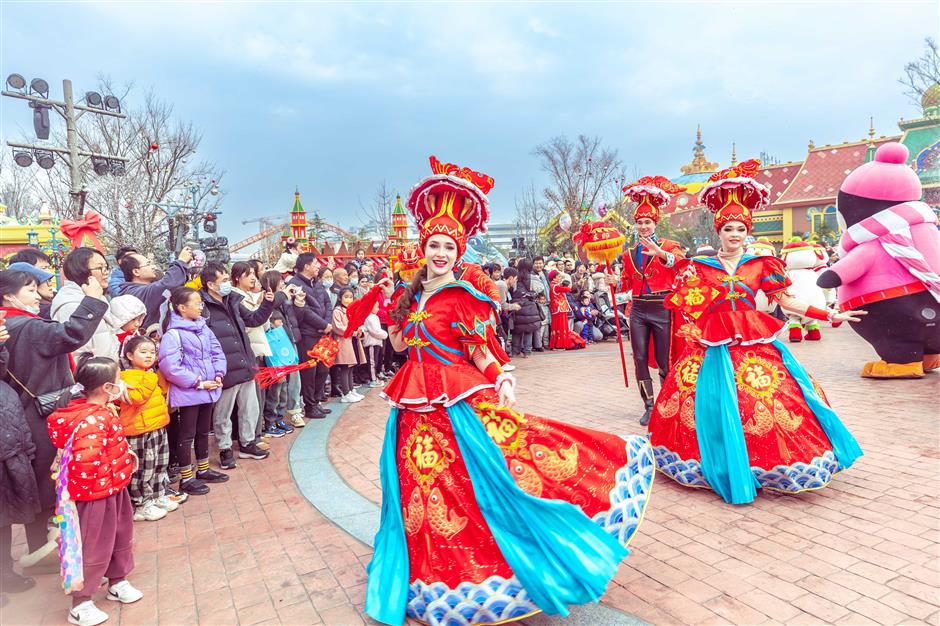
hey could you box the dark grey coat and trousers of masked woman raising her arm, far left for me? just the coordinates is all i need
[4,296,108,509]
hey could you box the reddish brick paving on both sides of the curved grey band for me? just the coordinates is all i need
[0,328,940,626]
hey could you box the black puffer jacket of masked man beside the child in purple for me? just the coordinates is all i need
[199,289,287,389]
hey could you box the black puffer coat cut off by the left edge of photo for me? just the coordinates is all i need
[0,344,40,526]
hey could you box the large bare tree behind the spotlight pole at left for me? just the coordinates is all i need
[5,77,222,253]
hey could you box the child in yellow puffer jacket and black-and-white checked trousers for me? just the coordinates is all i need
[120,336,179,521]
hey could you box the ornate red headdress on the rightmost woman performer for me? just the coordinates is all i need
[699,159,770,231]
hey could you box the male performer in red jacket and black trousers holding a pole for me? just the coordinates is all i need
[620,176,685,426]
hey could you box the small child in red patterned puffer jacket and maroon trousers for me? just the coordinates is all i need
[47,354,144,626]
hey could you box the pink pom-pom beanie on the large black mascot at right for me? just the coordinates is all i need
[840,141,921,202]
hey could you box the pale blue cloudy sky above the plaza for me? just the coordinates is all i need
[0,0,940,241]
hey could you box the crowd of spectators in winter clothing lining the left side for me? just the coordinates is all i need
[0,240,401,626]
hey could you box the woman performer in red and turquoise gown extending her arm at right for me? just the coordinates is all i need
[650,160,864,504]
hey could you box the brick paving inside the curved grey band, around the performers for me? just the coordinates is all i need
[330,327,940,626]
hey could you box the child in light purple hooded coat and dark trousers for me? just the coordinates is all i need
[160,287,228,495]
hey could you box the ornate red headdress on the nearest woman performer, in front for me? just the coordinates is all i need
[408,156,493,256]
